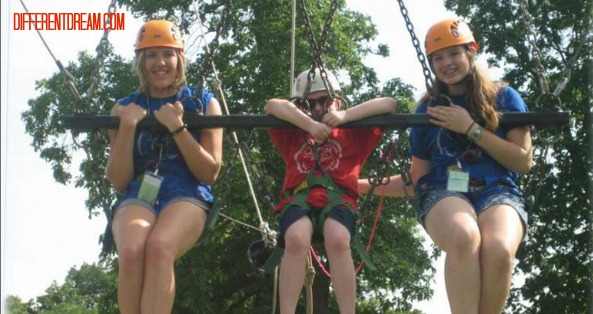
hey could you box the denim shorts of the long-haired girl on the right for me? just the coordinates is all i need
[417,186,528,235]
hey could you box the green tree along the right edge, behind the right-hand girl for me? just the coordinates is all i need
[446,0,593,313]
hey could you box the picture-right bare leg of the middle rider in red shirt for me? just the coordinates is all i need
[323,218,356,314]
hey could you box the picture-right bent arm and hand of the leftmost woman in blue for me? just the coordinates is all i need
[155,98,223,184]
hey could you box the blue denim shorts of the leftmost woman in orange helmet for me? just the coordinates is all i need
[113,177,212,216]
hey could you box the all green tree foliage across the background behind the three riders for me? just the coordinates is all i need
[22,0,593,313]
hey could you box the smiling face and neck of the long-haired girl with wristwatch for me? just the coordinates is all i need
[431,45,471,95]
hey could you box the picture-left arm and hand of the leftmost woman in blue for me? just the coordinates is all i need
[106,103,146,192]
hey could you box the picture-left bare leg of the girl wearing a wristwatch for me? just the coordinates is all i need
[425,197,481,314]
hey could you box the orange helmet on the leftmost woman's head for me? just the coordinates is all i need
[135,20,183,51]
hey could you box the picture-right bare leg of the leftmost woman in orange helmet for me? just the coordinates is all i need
[141,202,207,314]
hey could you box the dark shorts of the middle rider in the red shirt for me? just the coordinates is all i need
[278,205,356,248]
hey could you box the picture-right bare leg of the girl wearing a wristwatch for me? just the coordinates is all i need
[478,205,523,314]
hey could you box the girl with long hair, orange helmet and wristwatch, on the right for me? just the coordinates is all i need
[359,19,532,313]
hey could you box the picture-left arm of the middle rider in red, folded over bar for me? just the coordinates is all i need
[265,98,331,142]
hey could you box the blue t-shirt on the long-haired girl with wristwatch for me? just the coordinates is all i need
[410,87,528,195]
